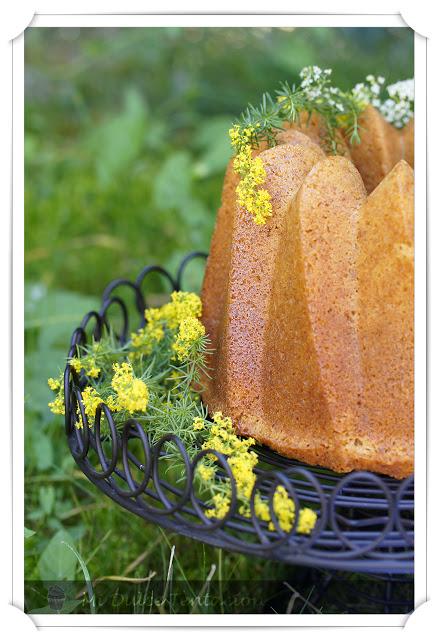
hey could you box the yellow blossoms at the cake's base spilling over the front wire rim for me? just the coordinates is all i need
[193,411,317,534]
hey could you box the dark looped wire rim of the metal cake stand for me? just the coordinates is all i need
[64,252,414,576]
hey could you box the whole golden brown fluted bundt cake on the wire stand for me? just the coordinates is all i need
[202,101,414,478]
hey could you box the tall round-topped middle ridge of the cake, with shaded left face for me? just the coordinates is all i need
[258,157,366,470]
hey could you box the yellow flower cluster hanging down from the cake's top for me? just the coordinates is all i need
[229,125,272,225]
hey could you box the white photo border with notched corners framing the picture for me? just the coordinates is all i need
[13,14,427,627]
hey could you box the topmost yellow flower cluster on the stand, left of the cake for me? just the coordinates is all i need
[131,291,202,357]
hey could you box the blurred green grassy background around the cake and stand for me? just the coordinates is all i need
[25,28,413,612]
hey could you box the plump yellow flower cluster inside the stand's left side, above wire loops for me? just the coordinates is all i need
[108,362,149,413]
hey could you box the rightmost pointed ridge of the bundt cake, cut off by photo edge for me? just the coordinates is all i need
[357,160,414,476]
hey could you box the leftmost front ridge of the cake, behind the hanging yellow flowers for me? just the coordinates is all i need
[202,144,323,429]
